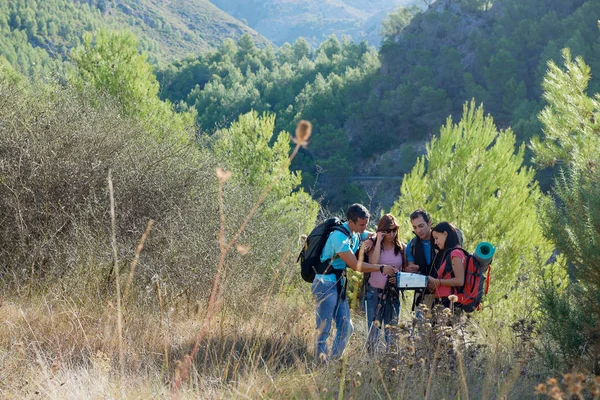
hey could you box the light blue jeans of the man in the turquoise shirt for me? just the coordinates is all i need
[311,279,354,361]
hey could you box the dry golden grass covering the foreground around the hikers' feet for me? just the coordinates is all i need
[0,281,556,399]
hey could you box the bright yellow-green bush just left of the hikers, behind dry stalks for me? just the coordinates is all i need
[209,112,319,279]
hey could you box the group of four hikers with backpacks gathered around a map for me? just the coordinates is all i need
[298,204,495,362]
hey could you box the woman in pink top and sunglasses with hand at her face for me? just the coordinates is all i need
[365,214,406,354]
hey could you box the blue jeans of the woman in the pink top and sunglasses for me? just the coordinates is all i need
[365,285,400,353]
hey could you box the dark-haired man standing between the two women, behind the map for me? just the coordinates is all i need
[404,208,435,314]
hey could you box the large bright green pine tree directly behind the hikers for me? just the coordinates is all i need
[392,101,551,305]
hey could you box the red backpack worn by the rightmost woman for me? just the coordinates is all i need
[446,247,492,312]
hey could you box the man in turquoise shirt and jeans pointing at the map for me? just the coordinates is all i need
[311,204,396,362]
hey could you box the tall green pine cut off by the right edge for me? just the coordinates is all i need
[531,49,600,372]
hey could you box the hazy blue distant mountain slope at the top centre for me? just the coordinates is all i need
[211,0,424,47]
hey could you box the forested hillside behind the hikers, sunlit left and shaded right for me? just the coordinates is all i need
[159,0,600,207]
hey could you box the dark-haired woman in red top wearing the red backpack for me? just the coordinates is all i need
[427,222,466,308]
